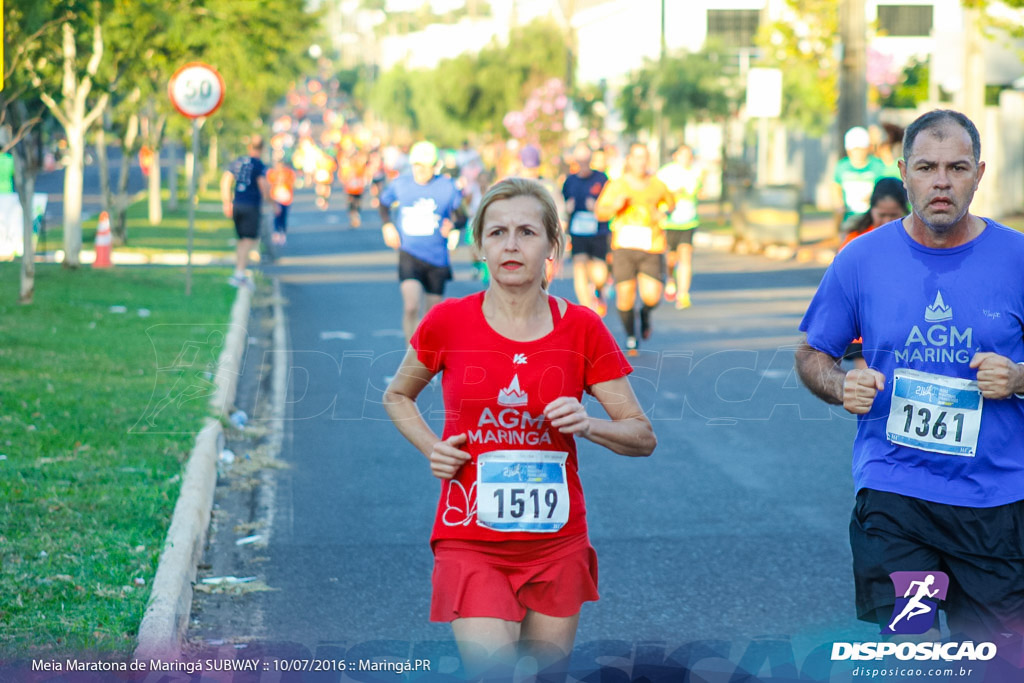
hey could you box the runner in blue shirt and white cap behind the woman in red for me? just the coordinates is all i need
[380,140,462,342]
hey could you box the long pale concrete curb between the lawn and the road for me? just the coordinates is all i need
[134,287,252,660]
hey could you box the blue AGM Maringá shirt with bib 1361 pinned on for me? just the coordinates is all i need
[800,219,1024,507]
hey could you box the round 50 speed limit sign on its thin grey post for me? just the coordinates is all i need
[167,61,224,296]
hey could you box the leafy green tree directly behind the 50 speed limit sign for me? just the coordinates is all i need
[109,0,318,235]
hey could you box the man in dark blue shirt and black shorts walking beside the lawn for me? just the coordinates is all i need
[220,135,270,287]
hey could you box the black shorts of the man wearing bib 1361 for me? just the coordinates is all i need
[850,491,1024,644]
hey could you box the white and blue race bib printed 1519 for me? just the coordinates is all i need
[476,451,569,532]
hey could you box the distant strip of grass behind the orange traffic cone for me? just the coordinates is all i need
[37,190,236,254]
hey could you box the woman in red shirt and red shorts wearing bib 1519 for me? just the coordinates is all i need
[384,178,657,673]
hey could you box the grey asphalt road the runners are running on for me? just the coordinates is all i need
[193,185,877,680]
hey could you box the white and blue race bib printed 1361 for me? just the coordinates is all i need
[886,370,984,456]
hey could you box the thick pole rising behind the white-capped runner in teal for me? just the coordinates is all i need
[837,0,867,148]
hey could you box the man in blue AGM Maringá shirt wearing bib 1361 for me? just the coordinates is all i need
[797,111,1024,651]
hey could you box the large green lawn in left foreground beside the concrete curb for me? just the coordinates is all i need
[0,263,234,660]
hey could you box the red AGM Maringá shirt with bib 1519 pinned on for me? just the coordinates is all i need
[411,292,633,543]
